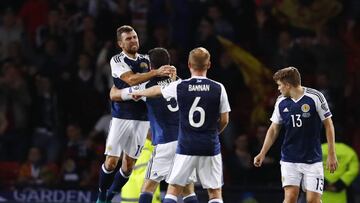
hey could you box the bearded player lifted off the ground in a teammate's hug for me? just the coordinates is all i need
[97,25,174,203]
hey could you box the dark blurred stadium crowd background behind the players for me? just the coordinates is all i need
[0,0,360,202]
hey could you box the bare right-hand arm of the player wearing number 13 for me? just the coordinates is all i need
[323,117,338,173]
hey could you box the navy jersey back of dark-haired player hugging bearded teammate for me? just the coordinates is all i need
[146,77,179,145]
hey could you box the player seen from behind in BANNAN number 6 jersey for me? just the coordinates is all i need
[133,47,230,203]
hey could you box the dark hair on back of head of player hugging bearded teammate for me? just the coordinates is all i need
[148,47,170,69]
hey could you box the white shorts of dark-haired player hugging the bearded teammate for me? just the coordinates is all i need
[145,141,197,184]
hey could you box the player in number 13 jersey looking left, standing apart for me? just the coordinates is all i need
[254,67,337,203]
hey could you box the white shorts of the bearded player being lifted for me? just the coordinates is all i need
[104,118,150,159]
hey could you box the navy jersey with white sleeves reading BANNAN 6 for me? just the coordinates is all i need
[161,76,230,156]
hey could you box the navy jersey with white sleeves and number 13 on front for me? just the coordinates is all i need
[270,88,332,164]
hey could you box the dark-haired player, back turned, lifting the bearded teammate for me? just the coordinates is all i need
[110,48,198,203]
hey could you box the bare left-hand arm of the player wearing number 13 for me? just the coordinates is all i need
[254,122,281,167]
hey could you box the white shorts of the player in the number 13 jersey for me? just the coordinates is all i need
[280,161,324,194]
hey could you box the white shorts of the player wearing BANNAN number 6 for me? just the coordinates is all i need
[166,154,223,189]
